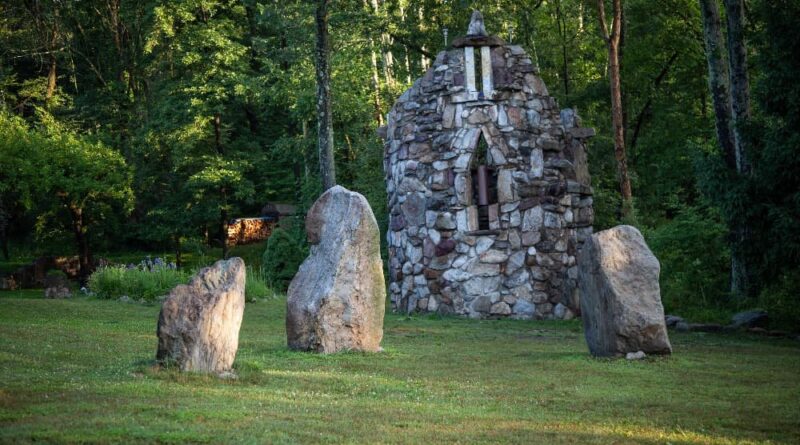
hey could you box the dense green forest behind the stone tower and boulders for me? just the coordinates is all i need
[0,0,800,328]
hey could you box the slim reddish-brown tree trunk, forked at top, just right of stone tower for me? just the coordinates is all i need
[597,0,633,218]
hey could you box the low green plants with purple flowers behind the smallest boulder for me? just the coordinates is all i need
[88,266,189,301]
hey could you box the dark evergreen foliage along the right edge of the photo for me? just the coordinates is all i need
[697,1,800,324]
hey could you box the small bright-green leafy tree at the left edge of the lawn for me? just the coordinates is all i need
[0,111,133,270]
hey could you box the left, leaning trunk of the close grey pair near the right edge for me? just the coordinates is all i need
[700,0,736,169]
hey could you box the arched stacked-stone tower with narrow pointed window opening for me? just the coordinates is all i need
[380,12,594,319]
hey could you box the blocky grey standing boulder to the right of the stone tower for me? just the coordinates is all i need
[578,226,672,356]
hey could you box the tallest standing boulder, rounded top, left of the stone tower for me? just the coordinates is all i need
[286,186,386,353]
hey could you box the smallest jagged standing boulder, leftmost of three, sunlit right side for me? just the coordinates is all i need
[156,258,245,374]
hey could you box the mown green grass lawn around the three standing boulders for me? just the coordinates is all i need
[0,292,800,444]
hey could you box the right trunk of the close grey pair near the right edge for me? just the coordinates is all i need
[725,0,750,173]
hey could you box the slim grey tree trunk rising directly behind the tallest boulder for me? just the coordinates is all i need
[315,0,336,190]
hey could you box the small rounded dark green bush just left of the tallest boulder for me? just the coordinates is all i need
[261,227,308,290]
